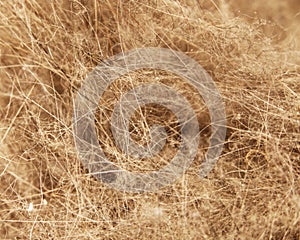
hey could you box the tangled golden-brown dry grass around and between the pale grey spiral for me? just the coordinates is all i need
[0,0,300,239]
